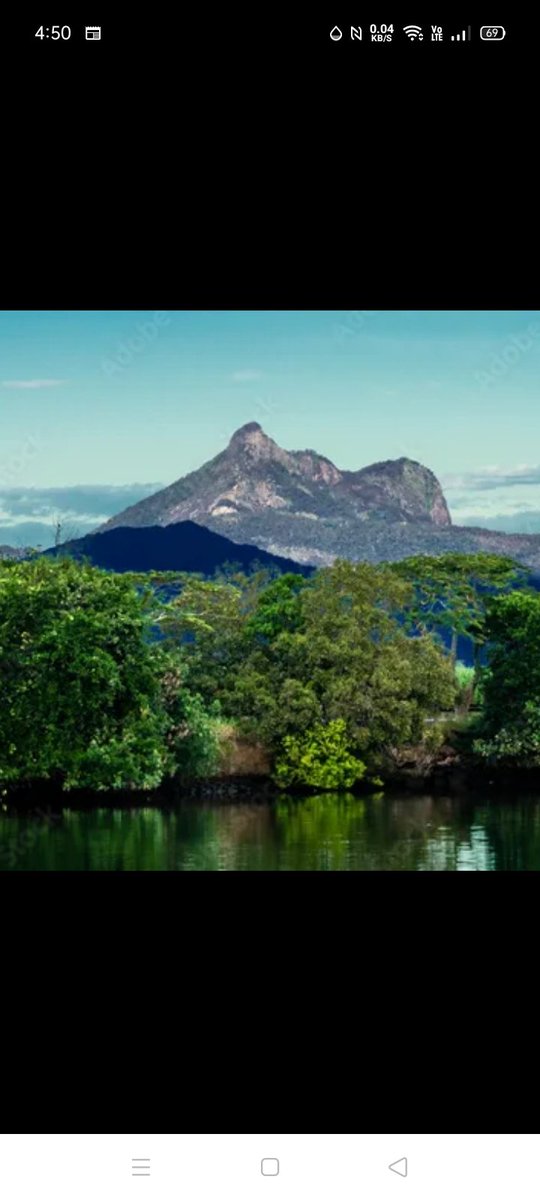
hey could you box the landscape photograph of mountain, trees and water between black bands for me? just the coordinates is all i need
[0,310,540,872]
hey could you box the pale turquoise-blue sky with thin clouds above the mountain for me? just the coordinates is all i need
[0,310,540,542]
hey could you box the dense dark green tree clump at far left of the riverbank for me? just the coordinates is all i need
[0,557,208,790]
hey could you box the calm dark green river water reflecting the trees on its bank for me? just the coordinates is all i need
[0,792,540,871]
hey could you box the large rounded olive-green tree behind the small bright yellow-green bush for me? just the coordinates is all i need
[228,562,455,756]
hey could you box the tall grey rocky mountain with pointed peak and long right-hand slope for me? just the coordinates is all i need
[97,421,540,571]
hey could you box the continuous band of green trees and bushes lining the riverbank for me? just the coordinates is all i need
[0,554,540,790]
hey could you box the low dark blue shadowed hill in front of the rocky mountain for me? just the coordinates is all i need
[44,521,307,575]
